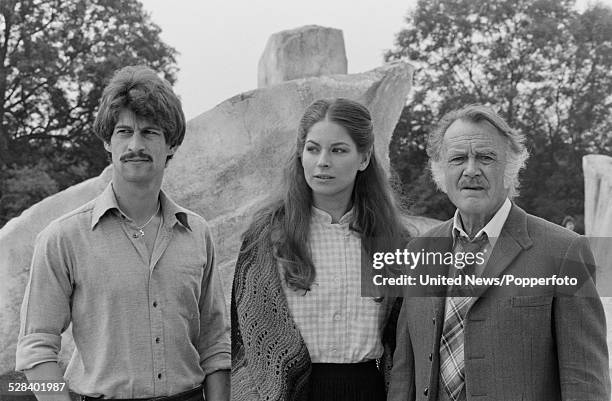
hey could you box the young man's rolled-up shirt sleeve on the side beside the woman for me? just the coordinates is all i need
[198,230,231,375]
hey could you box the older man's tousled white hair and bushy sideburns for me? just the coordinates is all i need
[427,104,529,199]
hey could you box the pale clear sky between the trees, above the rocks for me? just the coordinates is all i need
[141,0,612,119]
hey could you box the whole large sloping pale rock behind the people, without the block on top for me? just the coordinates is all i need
[0,63,431,373]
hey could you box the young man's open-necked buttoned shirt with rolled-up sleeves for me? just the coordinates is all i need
[16,185,231,398]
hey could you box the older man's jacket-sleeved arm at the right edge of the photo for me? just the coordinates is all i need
[554,237,610,401]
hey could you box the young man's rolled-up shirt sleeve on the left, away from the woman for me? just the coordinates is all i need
[15,226,72,370]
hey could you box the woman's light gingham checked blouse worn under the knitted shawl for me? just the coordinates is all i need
[283,207,385,363]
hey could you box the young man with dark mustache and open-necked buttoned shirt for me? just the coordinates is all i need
[16,66,230,401]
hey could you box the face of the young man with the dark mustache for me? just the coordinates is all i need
[104,109,176,184]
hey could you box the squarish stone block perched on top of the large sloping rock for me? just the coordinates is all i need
[257,25,347,88]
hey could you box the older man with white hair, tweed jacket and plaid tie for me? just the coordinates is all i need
[388,105,610,401]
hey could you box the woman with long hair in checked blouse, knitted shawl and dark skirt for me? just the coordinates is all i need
[231,98,406,401]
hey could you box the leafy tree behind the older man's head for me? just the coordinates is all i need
[385,0,612,227]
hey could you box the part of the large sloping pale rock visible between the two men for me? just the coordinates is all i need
[165,59,412,284]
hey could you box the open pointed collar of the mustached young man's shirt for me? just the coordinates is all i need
[91,182,191,230]
